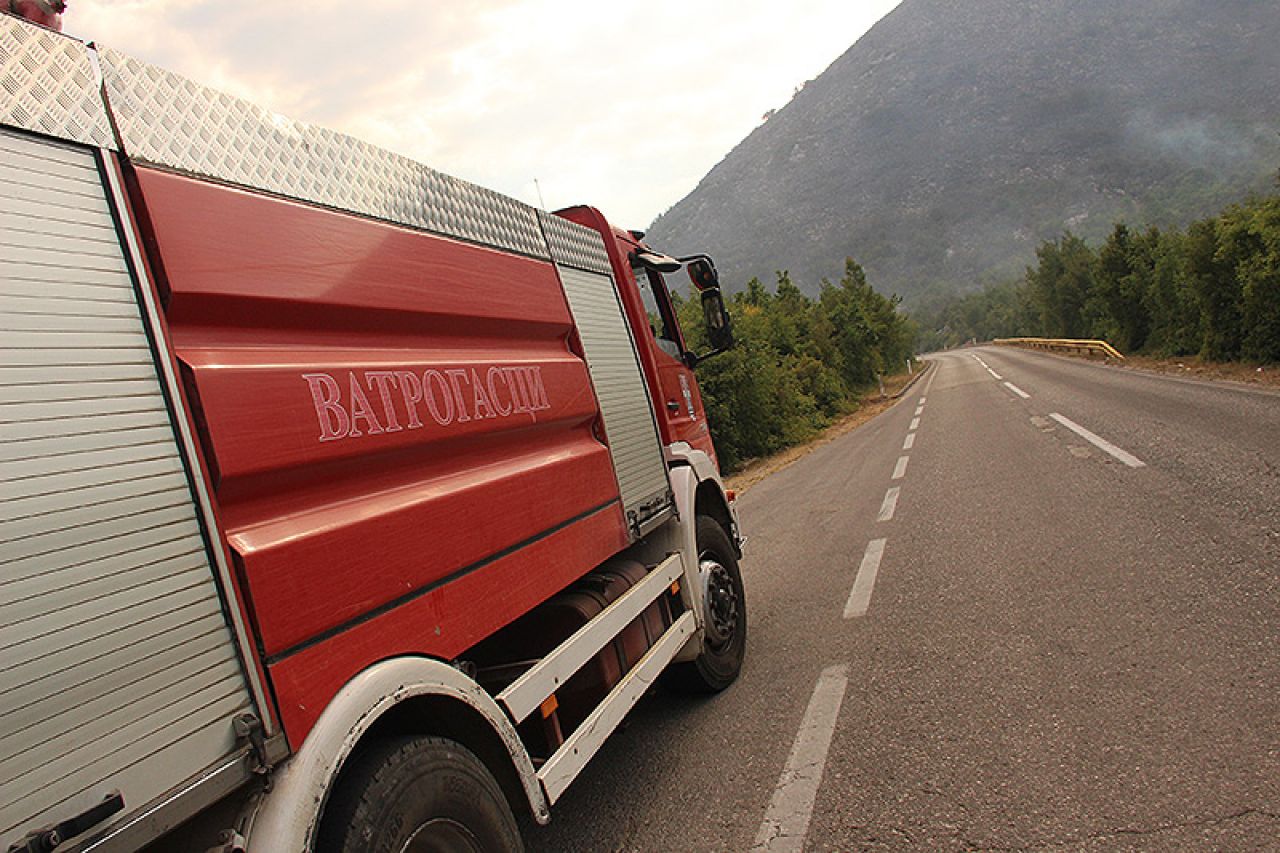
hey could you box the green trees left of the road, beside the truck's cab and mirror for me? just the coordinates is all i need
[677,259,915,473]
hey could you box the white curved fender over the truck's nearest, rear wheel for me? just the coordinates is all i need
[247,657,550,852]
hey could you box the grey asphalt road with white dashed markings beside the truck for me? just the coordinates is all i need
[529,348,1280,850]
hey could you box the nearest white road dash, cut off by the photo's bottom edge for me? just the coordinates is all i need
[751,663,849,853]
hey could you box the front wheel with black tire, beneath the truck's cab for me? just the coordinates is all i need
[664,515,746,693]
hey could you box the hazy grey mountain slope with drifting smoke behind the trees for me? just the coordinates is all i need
[649,0,1280,304]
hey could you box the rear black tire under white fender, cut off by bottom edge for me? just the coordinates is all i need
[316,736,525,853]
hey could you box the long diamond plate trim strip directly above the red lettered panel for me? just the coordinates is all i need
[99,49,549,259]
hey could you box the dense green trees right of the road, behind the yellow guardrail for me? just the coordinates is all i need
[913,189,1280,364]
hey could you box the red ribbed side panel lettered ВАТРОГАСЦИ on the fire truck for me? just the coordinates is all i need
[134,169,628,745]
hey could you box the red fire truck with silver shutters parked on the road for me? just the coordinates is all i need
[0,14,746,852]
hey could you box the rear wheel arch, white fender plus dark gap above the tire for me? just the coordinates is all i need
[248,657,549,850]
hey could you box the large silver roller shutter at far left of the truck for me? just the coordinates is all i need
[0,131,255,845]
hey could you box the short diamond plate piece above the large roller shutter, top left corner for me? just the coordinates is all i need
[0,14,115,150]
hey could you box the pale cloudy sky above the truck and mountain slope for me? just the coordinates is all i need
[63,0,900,228]
